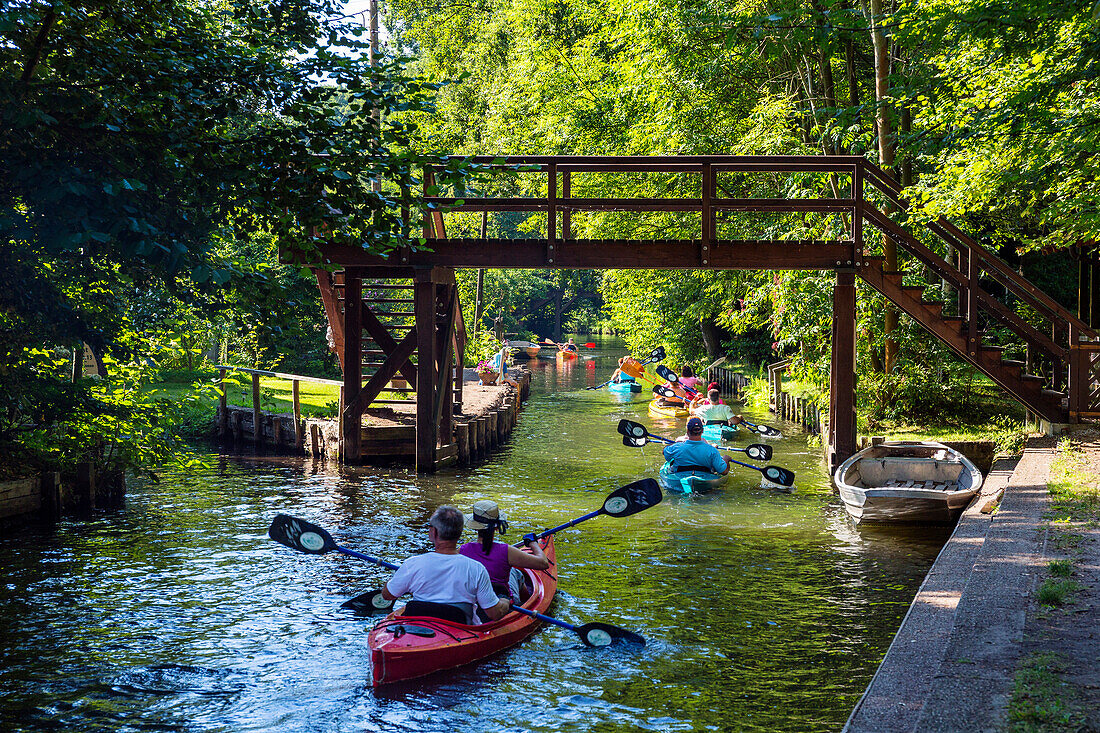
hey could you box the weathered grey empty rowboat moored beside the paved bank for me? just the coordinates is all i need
[833,441,982,524]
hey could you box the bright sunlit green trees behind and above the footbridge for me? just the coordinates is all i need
[389,0,1100,422]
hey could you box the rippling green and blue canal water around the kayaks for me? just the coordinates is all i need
[0,344,947,733]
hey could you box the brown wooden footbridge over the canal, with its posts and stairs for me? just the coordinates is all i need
[301,156,1100,471]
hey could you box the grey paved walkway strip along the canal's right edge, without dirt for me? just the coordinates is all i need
[844,439,1055,733]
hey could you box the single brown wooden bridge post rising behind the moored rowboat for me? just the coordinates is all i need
[828,270,856,471]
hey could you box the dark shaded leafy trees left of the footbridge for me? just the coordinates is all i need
[0,0,461,468]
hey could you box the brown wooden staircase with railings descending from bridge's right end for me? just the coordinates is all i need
[855,163,1100,423]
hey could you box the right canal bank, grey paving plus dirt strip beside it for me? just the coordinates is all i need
[845,431,1100,733]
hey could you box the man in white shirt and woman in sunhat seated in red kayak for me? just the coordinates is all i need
[382,500,550,625]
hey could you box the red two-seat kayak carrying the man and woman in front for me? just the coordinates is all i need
[367,535,558,687]
